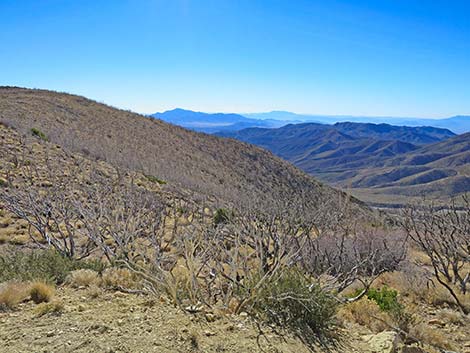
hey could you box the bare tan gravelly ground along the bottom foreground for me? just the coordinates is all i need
[0,287,414,353]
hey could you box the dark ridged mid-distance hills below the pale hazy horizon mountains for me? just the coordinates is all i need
[220,123,470,203]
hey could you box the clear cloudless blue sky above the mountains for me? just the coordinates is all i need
[0,0,470,117]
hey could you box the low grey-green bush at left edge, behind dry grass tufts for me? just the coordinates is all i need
[0,249,105,284]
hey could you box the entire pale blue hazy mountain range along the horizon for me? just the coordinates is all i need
[151,109,470,134]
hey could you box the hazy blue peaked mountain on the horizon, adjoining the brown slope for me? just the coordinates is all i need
[150,108,285,133]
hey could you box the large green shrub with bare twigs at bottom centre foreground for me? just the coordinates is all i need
[248,268,337,343]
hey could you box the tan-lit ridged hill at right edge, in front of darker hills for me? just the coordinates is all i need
[348,133,470,204]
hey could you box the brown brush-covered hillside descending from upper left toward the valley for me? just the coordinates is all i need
[0,87,363,217]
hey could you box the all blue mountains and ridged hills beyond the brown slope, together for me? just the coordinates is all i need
[153,109,470,206]
